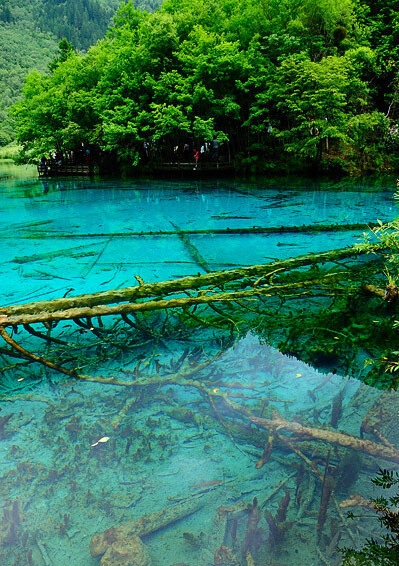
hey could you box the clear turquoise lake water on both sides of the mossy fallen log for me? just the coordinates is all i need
[0,165,399,566]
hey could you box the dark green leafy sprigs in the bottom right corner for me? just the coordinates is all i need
[342,469,399,566]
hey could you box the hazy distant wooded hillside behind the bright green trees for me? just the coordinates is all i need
[0,0,161,147]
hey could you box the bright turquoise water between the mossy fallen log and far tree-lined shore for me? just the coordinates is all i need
[0,174,396,304]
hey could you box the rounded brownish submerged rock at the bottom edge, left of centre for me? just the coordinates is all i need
[100,535,152,566]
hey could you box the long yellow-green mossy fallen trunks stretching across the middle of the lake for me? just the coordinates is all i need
[0,245,379,327]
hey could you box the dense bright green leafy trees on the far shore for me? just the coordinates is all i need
[5,0,399,174]
